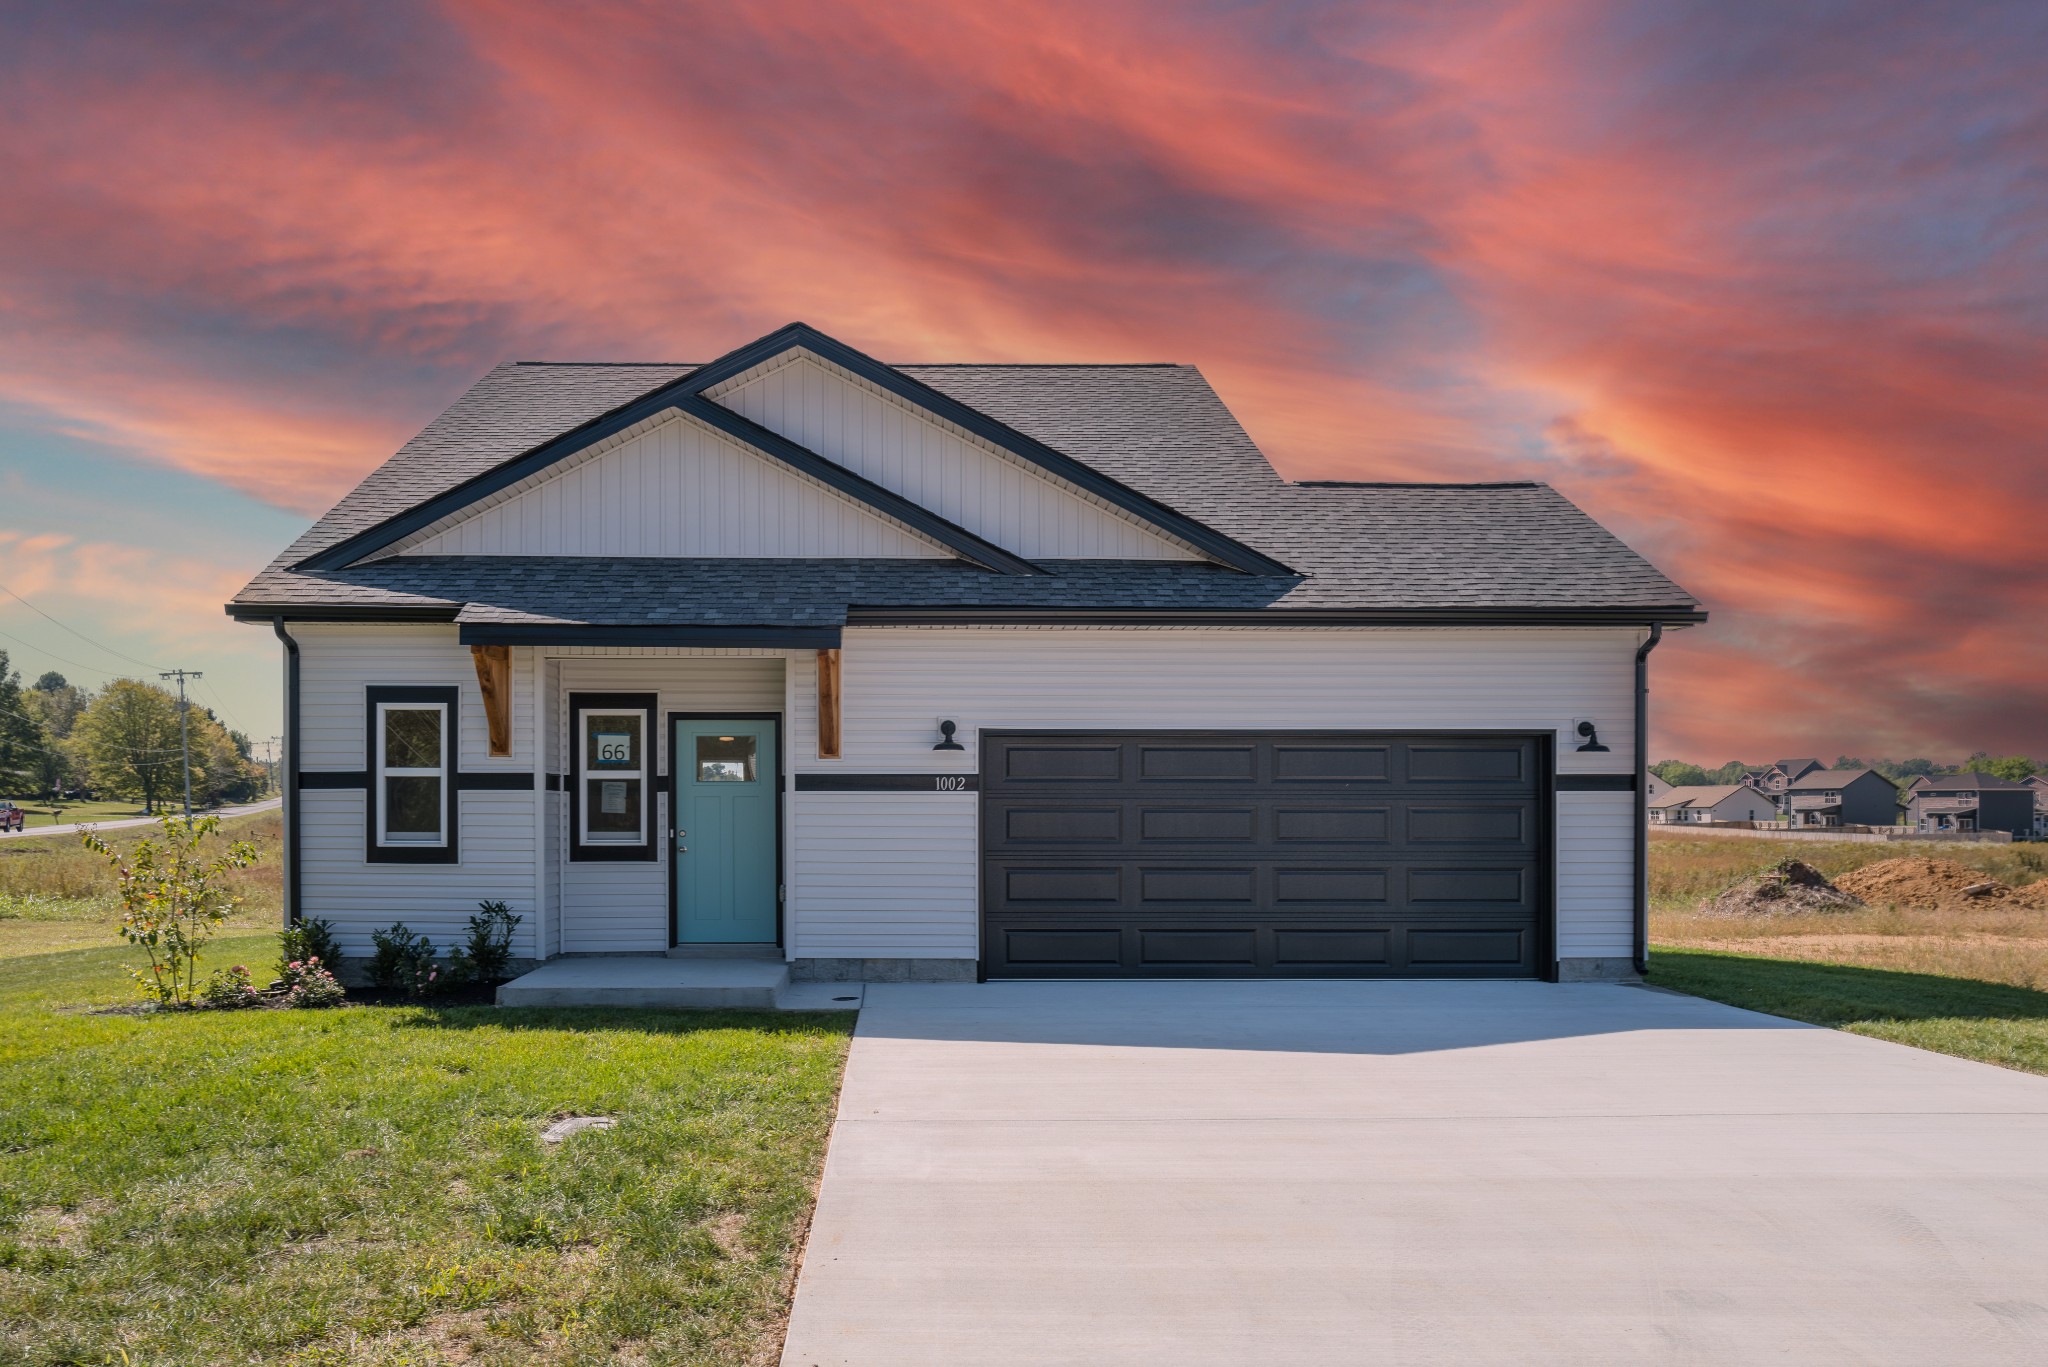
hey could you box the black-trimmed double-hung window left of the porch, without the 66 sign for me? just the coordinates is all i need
[367,687,461,863]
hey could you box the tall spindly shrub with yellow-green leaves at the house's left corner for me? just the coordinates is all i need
[82,814,256,1006]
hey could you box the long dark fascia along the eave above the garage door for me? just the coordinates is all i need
[846,607,1706,627]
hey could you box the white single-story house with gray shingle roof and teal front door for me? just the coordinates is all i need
[227,324,1704,980]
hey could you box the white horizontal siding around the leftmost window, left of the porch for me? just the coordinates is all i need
[291,623,547,957]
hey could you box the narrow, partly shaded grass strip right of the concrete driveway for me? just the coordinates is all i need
[1649,945,2048,1074]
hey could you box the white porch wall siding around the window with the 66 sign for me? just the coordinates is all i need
[555,648,788,953]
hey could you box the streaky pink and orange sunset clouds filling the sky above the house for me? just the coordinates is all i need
[0,0,2048,762]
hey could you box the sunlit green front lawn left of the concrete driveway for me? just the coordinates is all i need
[0,937,852,1367]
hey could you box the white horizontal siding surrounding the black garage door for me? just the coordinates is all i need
[788,627,1640,959]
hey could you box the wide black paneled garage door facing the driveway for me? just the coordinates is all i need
[981,732,1548,978]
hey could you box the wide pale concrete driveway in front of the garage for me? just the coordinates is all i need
[782,982,2048,1367]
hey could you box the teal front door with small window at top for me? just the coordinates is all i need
[668,717,782,945]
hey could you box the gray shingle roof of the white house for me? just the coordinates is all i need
[231,363,1694,625]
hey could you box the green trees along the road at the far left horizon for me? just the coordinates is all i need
[0,650,268,812]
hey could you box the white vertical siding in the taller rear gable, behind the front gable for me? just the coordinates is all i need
[709,353,1200,560]
